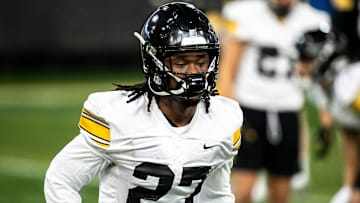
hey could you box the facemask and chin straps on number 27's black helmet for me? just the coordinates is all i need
[135,33,219,102]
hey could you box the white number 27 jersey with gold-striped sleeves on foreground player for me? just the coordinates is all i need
[45,91,243,203]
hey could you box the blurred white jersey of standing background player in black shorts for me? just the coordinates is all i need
[223,0,330,110]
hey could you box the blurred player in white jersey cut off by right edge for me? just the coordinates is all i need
[331,61,360,203]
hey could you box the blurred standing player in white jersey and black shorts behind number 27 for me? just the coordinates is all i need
[218,0,330,203]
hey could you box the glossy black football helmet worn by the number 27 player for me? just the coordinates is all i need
[134,2,220,99]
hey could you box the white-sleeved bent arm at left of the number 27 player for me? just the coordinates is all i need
[44,135,109,202]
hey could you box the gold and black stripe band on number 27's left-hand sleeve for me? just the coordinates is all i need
[79,109,110,145]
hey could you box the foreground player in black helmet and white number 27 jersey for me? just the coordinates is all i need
[45,2,243,203]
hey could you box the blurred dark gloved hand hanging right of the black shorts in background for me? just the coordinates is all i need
[315,126,332,159]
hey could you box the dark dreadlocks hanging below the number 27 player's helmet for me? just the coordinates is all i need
[114,82,219,113]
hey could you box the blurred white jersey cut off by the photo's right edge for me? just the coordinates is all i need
[331,62,360,130]
